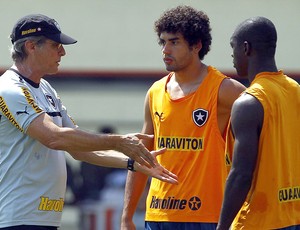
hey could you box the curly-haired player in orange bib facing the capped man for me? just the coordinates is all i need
[121,6,244,230]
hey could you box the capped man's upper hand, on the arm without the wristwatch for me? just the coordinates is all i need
[118,133,156,168]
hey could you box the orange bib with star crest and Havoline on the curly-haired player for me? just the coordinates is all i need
[145,67,227,223]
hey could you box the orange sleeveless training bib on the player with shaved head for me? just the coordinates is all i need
[227,71,300,230]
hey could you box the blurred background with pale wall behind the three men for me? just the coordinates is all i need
[0,0,300,230]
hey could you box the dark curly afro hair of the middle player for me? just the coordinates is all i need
[154,5,212,60]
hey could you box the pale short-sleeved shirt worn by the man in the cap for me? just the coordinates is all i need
[0,69,76,227]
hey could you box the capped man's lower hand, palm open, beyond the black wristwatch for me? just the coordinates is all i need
[136,148,178,184]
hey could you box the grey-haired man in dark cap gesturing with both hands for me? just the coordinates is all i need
[0,14,177,230]
